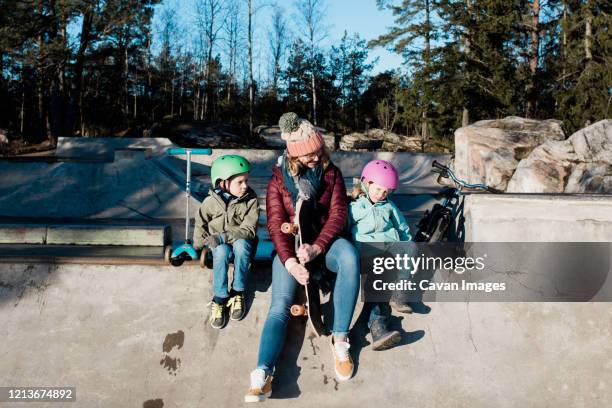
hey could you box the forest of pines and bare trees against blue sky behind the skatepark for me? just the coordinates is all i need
[0,0,612,150]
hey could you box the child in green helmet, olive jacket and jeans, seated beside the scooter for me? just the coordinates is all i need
[193,155,259,329]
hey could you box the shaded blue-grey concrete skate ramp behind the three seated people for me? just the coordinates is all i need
[0,143,448,220]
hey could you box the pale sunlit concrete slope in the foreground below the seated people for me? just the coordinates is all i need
[0,264,612,408]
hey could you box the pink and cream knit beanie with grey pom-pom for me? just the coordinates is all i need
[278,112,325,157]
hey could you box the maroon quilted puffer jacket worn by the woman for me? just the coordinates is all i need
[266,163,348,264]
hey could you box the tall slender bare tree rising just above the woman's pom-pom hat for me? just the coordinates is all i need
[297,0,326,125]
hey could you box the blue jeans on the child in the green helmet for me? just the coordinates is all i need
[212,239,254,299]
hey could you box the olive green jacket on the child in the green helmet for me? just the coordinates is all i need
[193,187,259,250]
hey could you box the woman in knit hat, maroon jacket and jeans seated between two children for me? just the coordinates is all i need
[245,113,359,402]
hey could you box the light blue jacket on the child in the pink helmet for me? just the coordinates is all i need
[349,195,412,242]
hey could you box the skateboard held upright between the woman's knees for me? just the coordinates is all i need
[281,198,329,337]
